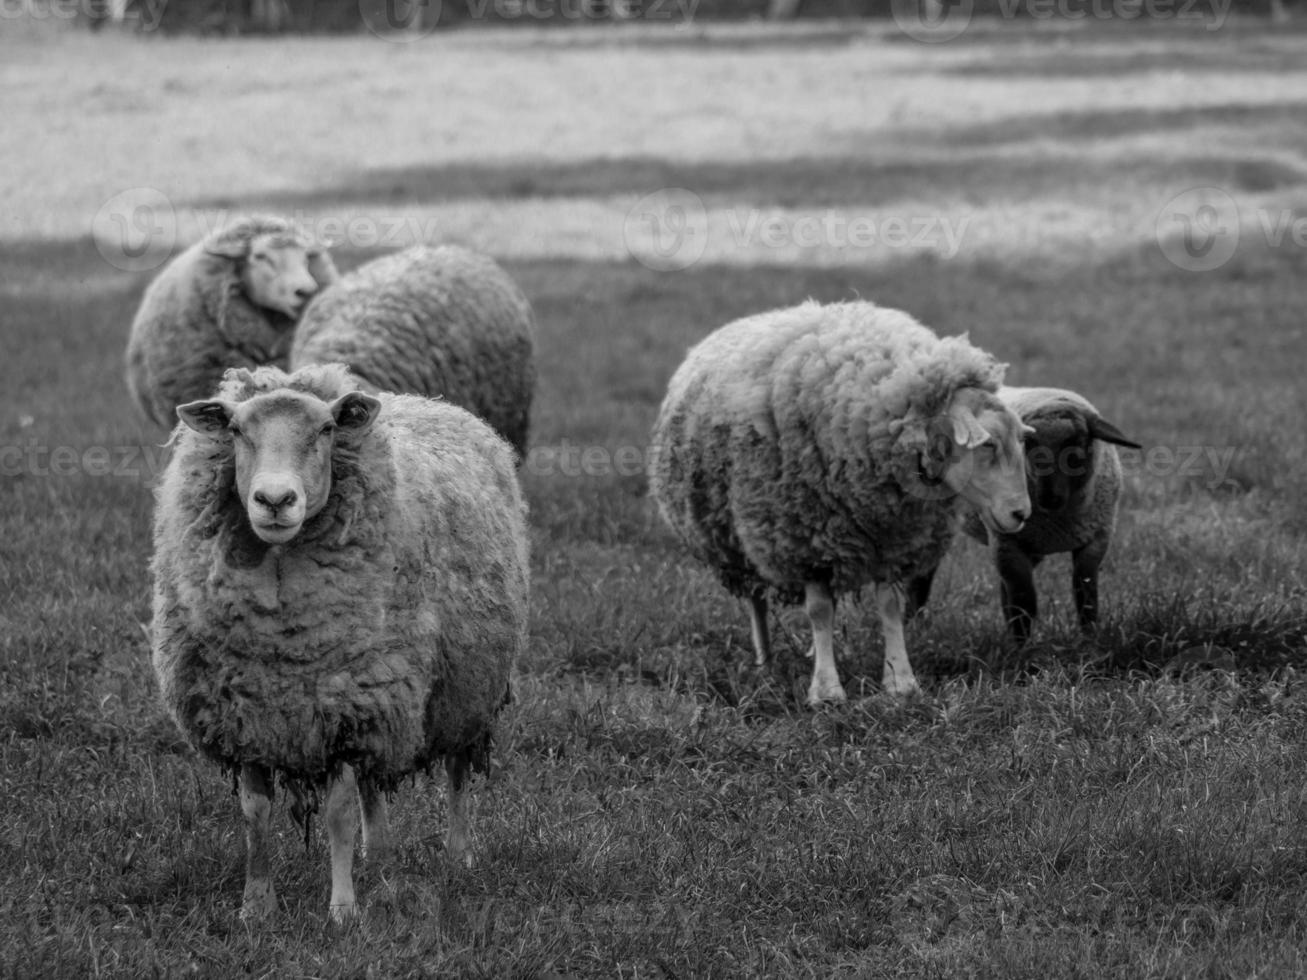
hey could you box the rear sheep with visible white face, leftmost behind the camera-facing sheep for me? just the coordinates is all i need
[127,217,336,429]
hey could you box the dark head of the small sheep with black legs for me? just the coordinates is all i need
[1026,404,1140,514]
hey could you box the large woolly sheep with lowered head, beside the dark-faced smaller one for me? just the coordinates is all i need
[650,303,1030,704]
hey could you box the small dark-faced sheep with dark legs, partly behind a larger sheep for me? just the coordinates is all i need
[911,387,1140,644]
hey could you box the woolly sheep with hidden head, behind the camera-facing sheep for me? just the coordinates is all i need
[290,246,536,459]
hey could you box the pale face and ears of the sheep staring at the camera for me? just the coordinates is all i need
[176,388,382,545]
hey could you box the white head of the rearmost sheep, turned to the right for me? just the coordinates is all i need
[204,218,337,319]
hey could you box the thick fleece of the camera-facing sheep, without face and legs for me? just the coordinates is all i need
[153,366,528,787]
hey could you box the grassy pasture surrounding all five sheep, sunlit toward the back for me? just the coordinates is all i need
[0,21,1307,980]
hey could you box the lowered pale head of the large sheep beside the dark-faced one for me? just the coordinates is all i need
[890,387,1031,534]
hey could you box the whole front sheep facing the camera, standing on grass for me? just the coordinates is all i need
[152,365,528,919]
